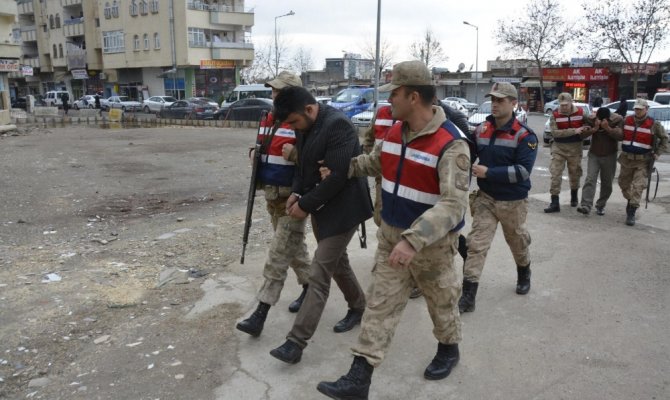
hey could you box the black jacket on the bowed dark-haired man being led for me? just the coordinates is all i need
[293,105,372,240]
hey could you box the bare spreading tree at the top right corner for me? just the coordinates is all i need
[579,0,670,95]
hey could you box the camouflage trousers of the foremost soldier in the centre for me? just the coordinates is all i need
[352,222,462,367]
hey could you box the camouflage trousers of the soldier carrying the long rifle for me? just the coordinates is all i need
[256,196,311,305]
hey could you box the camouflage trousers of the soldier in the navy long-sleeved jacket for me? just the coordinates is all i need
[463,190,531,282]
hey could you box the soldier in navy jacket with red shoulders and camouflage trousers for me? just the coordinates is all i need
[458,83,537,313]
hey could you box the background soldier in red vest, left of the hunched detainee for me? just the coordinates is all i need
[544,93,586,213]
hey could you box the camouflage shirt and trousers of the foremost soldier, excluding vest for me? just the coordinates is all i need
[350,107,470,366]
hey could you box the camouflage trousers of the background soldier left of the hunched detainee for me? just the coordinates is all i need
[549,142,582,196]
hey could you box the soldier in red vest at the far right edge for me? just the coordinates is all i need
[619,99,668,226]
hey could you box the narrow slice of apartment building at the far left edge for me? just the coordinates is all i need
[0,1,21,125]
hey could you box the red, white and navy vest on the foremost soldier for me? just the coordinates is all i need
[380,121,465,231]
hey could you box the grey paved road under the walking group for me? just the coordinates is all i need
[207,116,670,400]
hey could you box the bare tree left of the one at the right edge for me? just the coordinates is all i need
[495,0,574,109]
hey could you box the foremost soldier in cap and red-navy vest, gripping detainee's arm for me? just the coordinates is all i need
[317,61,470,399]
